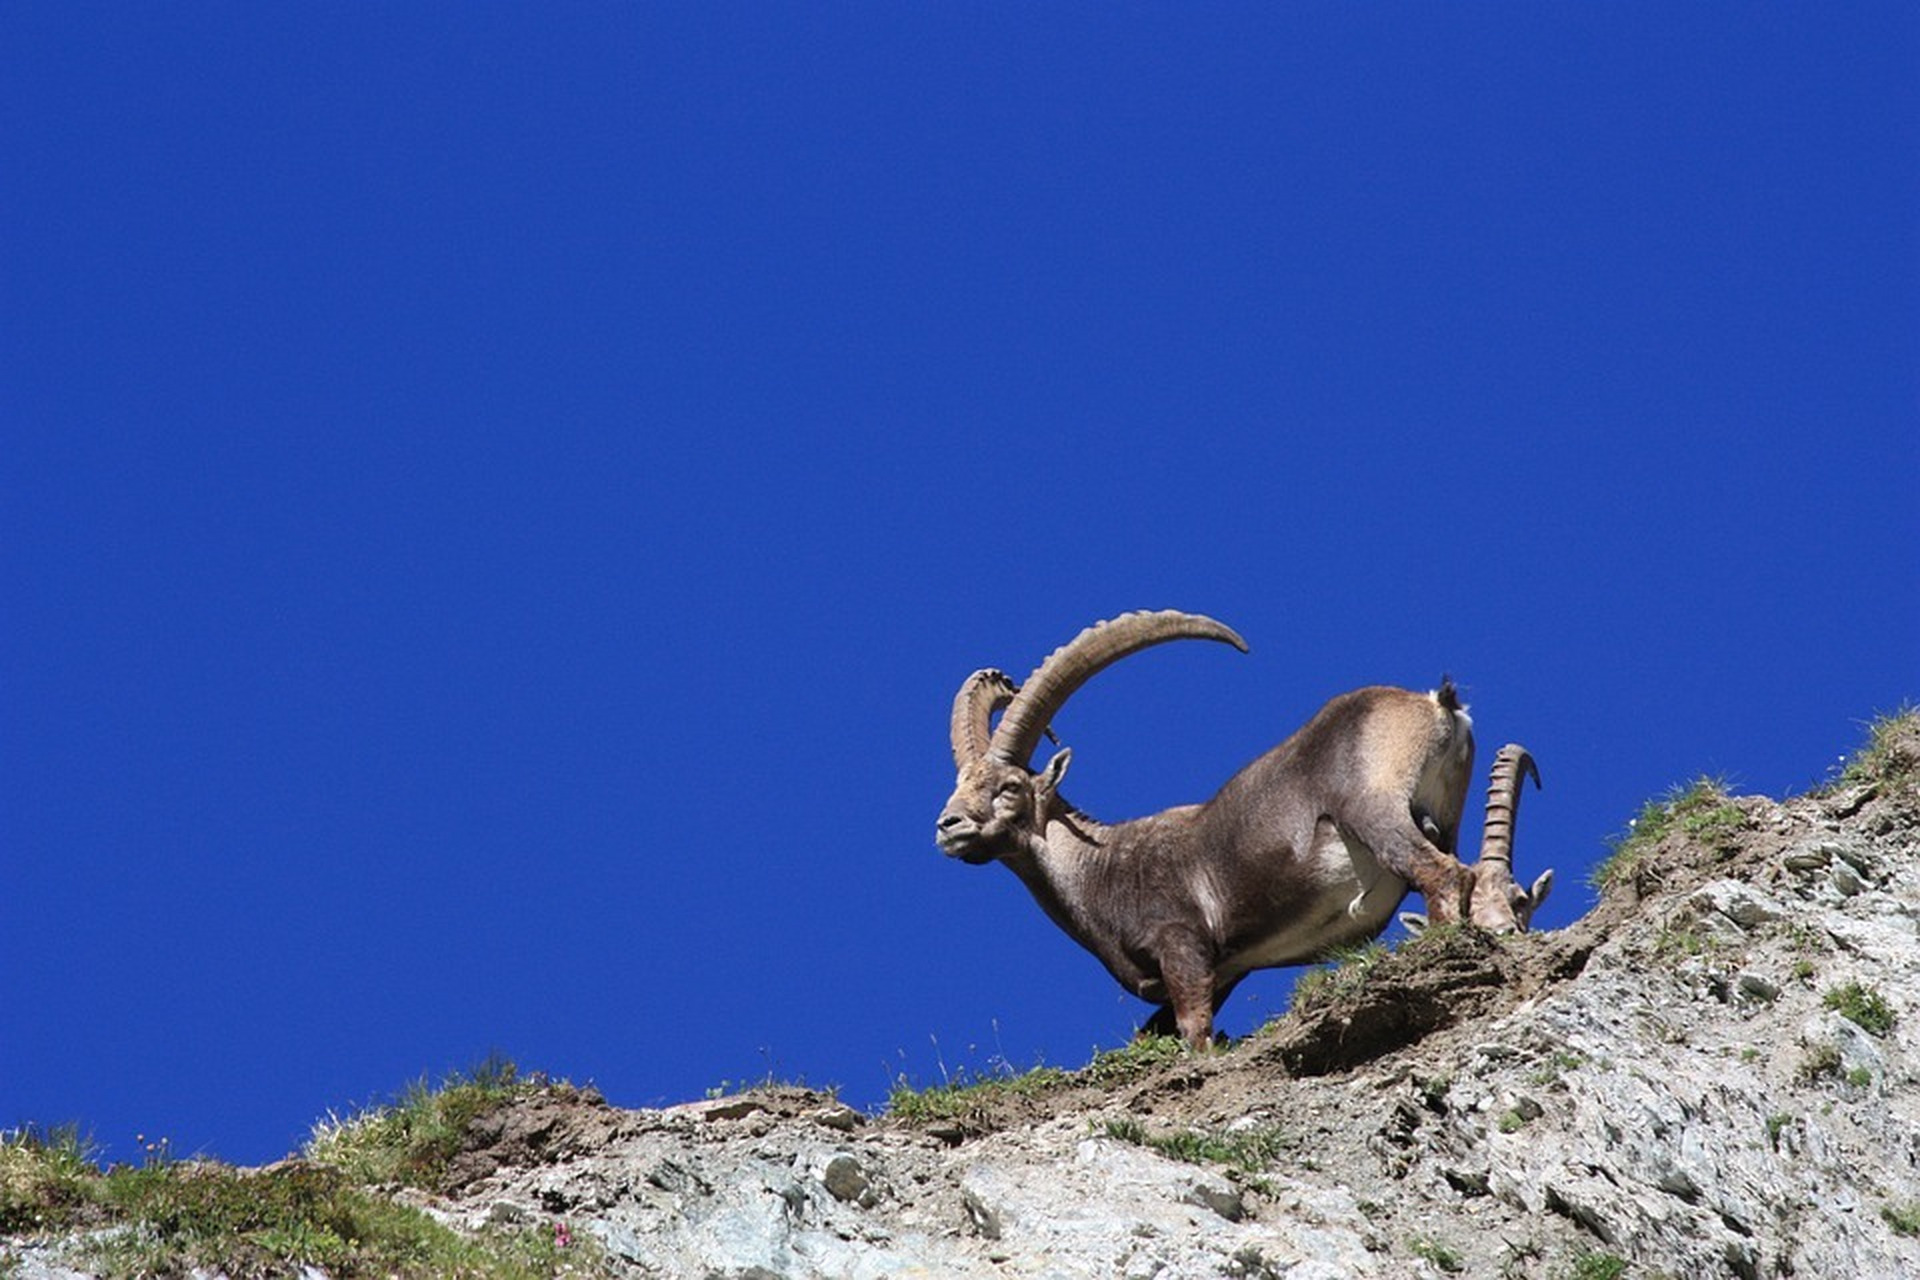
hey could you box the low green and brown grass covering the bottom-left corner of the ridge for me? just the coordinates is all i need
[0,1059,607,1280]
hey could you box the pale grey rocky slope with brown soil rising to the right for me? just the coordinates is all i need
[15,716,1920,1280]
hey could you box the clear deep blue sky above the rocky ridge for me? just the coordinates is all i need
[0,2,1920,1161]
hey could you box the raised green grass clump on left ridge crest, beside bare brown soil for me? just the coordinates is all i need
[303,1054,552,1190]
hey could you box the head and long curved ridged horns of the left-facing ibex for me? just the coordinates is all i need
[935,610,1246,864]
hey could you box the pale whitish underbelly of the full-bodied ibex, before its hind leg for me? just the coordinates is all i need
[1215,818,1407,981]
